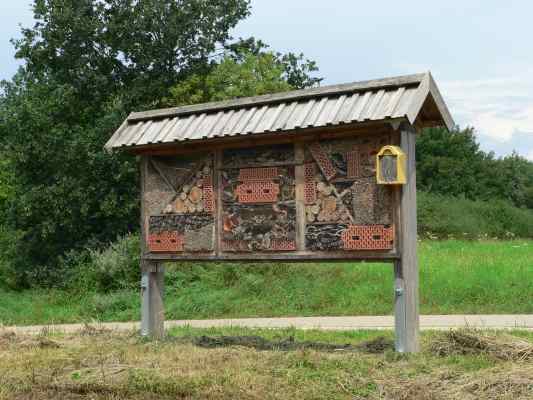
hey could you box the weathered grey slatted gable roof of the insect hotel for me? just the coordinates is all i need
[105,73,453,149]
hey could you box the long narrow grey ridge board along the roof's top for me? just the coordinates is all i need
[127,73,427,122]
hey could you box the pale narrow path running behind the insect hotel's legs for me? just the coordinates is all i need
[4,315,533,333]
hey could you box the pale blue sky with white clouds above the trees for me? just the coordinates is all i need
[0,0,533,160]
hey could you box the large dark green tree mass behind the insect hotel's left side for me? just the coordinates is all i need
[0,0,316,286]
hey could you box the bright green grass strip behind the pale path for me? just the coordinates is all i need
[0,240,533,325]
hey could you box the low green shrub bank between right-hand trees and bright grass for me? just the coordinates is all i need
[418,192,533,239]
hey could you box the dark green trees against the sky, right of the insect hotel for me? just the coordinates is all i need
[416,128,533,208]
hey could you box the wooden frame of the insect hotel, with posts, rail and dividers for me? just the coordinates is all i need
[141,123,419,352]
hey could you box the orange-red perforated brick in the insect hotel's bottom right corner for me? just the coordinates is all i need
[341,225,394,250]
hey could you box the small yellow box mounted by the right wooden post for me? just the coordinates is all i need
[376,146,407,185]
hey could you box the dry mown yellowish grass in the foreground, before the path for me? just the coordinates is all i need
[0,328,533,400]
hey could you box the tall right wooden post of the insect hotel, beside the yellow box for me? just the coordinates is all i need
[394,124,420,353]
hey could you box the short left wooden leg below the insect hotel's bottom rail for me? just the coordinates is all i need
[141,260,165,339]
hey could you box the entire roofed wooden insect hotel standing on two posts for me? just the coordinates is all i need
[106,73,453,352]
